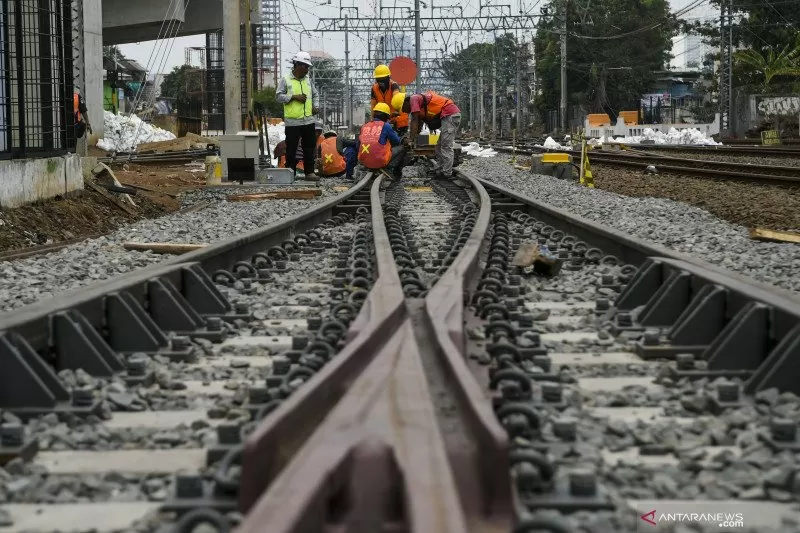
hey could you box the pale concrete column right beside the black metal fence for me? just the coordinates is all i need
[81,0,103,138]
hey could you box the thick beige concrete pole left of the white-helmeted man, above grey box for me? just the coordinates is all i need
[222,0,242,135]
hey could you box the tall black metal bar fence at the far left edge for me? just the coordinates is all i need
[0,0,75,159]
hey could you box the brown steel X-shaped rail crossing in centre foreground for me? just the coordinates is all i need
[239,172,513,533]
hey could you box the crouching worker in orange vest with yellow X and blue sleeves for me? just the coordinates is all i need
[358,102,405,178]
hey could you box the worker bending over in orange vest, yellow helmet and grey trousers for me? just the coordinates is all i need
[392,91,461,178]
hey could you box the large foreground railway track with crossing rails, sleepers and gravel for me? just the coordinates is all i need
[0,169,800,533]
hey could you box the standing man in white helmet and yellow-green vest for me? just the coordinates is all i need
[275,52,319,181]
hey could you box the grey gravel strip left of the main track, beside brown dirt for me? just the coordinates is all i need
[0,180,353,311]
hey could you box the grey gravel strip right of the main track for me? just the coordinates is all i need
[460,158,800,293]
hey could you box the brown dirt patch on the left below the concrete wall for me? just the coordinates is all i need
[0,158,205,252]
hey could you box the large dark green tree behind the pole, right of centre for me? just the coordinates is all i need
[534,0,678,118]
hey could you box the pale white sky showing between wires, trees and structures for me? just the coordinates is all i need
[120,0,711,77]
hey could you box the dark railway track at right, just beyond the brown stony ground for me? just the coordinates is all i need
[478,146,800,184]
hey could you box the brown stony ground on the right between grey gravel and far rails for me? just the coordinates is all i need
[592,164,800,230]
